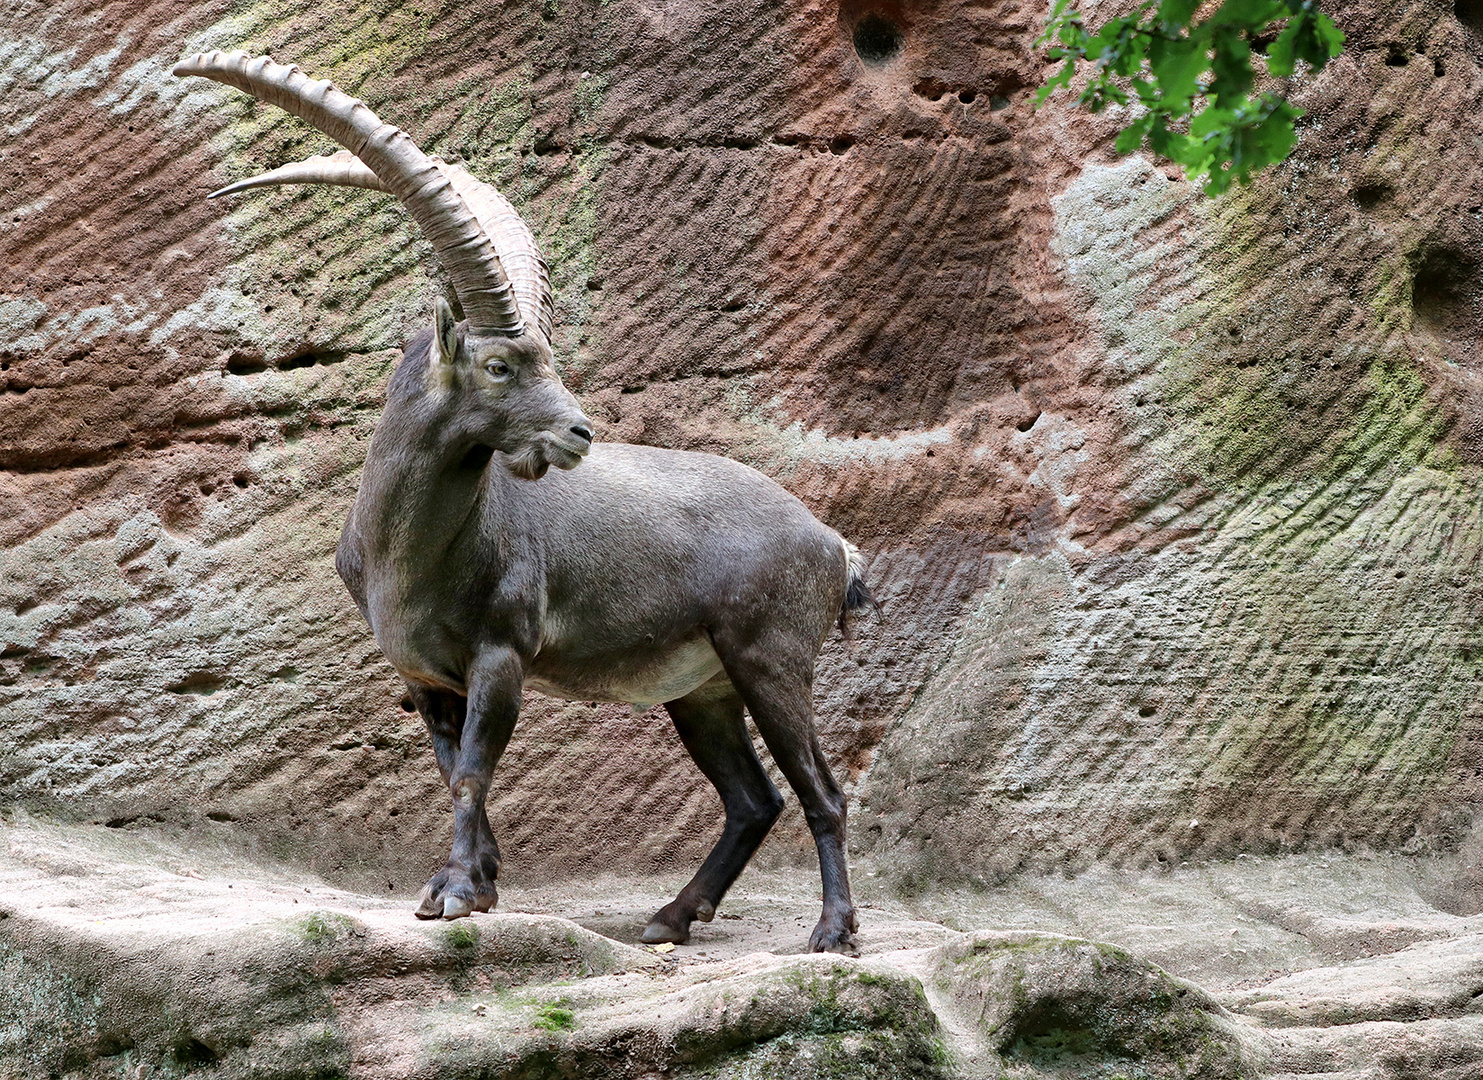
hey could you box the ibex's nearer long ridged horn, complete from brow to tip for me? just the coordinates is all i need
[174,50,525,335]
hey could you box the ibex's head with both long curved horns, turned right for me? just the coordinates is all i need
[175,52,592,479]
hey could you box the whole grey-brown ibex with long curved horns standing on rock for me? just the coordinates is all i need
[175,52,873,952]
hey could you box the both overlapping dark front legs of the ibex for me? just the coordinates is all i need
[414,650,523,918]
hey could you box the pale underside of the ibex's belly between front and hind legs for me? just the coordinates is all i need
[525,636,721,708]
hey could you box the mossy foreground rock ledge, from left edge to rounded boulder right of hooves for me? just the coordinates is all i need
[0,823,1247,1080]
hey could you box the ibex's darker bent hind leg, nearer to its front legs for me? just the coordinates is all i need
[644,685,783,945]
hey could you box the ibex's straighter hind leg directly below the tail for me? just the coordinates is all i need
[712,632,859,955]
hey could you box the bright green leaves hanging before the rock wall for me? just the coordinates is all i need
[1037,0,1344,194]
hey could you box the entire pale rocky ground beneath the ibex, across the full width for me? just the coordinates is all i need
[0,814,1483,1080]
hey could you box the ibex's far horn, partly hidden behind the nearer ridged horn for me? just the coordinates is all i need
[206,150,555,341]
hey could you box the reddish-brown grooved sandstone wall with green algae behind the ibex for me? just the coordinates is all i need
[0,0,1483,887]
